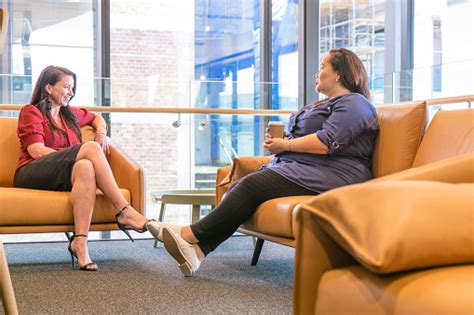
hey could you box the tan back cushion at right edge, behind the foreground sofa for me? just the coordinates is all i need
[413,109,474,167]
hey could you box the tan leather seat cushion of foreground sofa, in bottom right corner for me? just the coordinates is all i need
[315,265,474,315]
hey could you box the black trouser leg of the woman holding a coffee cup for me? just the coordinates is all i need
[191,169,316,255]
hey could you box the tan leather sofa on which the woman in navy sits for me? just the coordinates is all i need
[216,102,430,265]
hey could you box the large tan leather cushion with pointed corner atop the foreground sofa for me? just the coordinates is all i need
[303,181,474,273]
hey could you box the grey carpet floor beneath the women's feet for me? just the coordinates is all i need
[1,236,294,314]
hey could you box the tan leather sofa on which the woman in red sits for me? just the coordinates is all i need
[0,117,145,234]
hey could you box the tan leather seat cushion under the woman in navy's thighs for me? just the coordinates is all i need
[242,196,314,238]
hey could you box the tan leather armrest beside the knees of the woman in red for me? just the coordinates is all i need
[107,145,146,216]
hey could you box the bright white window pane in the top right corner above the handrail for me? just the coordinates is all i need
[413,0,474,99]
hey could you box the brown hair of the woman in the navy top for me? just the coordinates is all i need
[329,48,370,100]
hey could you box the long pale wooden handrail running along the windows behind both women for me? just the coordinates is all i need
[0,94,474,116]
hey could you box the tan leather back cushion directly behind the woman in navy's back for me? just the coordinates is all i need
[372,102,427,177]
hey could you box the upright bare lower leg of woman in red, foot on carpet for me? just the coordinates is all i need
[71,160,96,266]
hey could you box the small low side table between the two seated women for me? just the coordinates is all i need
[151,189,216,247]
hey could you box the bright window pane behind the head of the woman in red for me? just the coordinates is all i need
[1,0,94,104]
